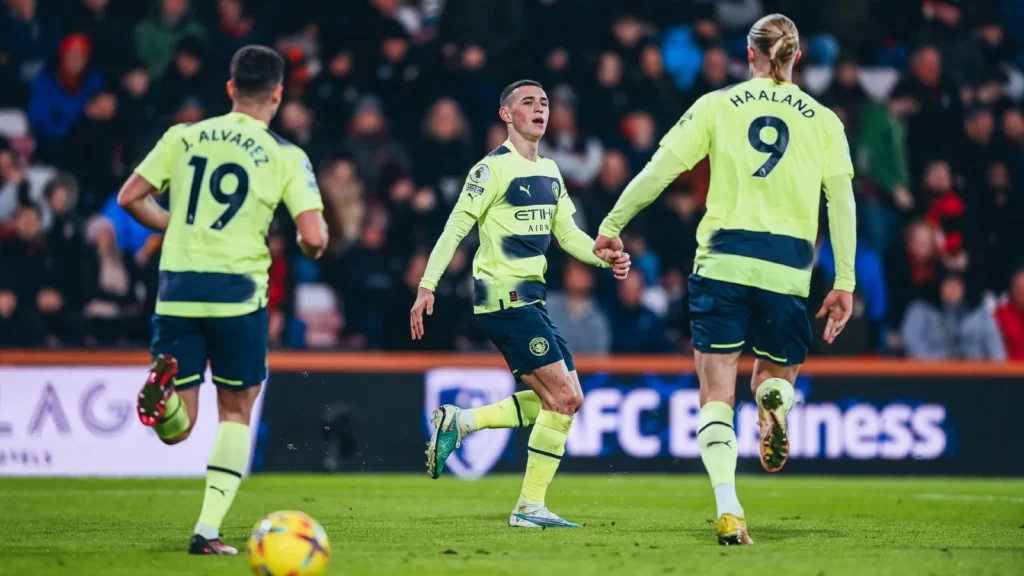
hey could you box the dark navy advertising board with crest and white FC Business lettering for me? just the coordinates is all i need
[261,368,1024,479]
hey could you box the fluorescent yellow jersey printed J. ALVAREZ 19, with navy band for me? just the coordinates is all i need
[135,113,324,318]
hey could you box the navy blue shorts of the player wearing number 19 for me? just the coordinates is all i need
[153,308,268,389]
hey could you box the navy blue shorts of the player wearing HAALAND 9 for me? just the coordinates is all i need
[688,274,811,366]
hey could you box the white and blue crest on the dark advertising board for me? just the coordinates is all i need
[423,368,515,480]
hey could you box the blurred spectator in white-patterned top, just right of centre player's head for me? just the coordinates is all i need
[539,100,604,189]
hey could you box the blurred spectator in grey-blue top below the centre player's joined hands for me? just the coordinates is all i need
[548,258,611,355]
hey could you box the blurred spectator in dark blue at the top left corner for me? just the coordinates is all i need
[0,0,59,108]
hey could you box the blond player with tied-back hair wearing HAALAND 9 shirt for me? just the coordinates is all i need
[595,14,856,544]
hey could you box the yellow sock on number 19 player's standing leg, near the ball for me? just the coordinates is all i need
[196,422,252,539]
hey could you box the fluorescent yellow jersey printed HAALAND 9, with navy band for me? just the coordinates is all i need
[601,78,854,297]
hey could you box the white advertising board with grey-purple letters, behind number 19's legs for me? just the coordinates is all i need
[0,366,264,477]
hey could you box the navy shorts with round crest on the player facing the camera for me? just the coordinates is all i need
[476,302,575,376]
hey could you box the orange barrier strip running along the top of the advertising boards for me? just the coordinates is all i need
[0,351,1024,379]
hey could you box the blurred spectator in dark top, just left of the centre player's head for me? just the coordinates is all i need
[415,96,478,209]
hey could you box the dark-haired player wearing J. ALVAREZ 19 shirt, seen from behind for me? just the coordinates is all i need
[118,46,327,556]
